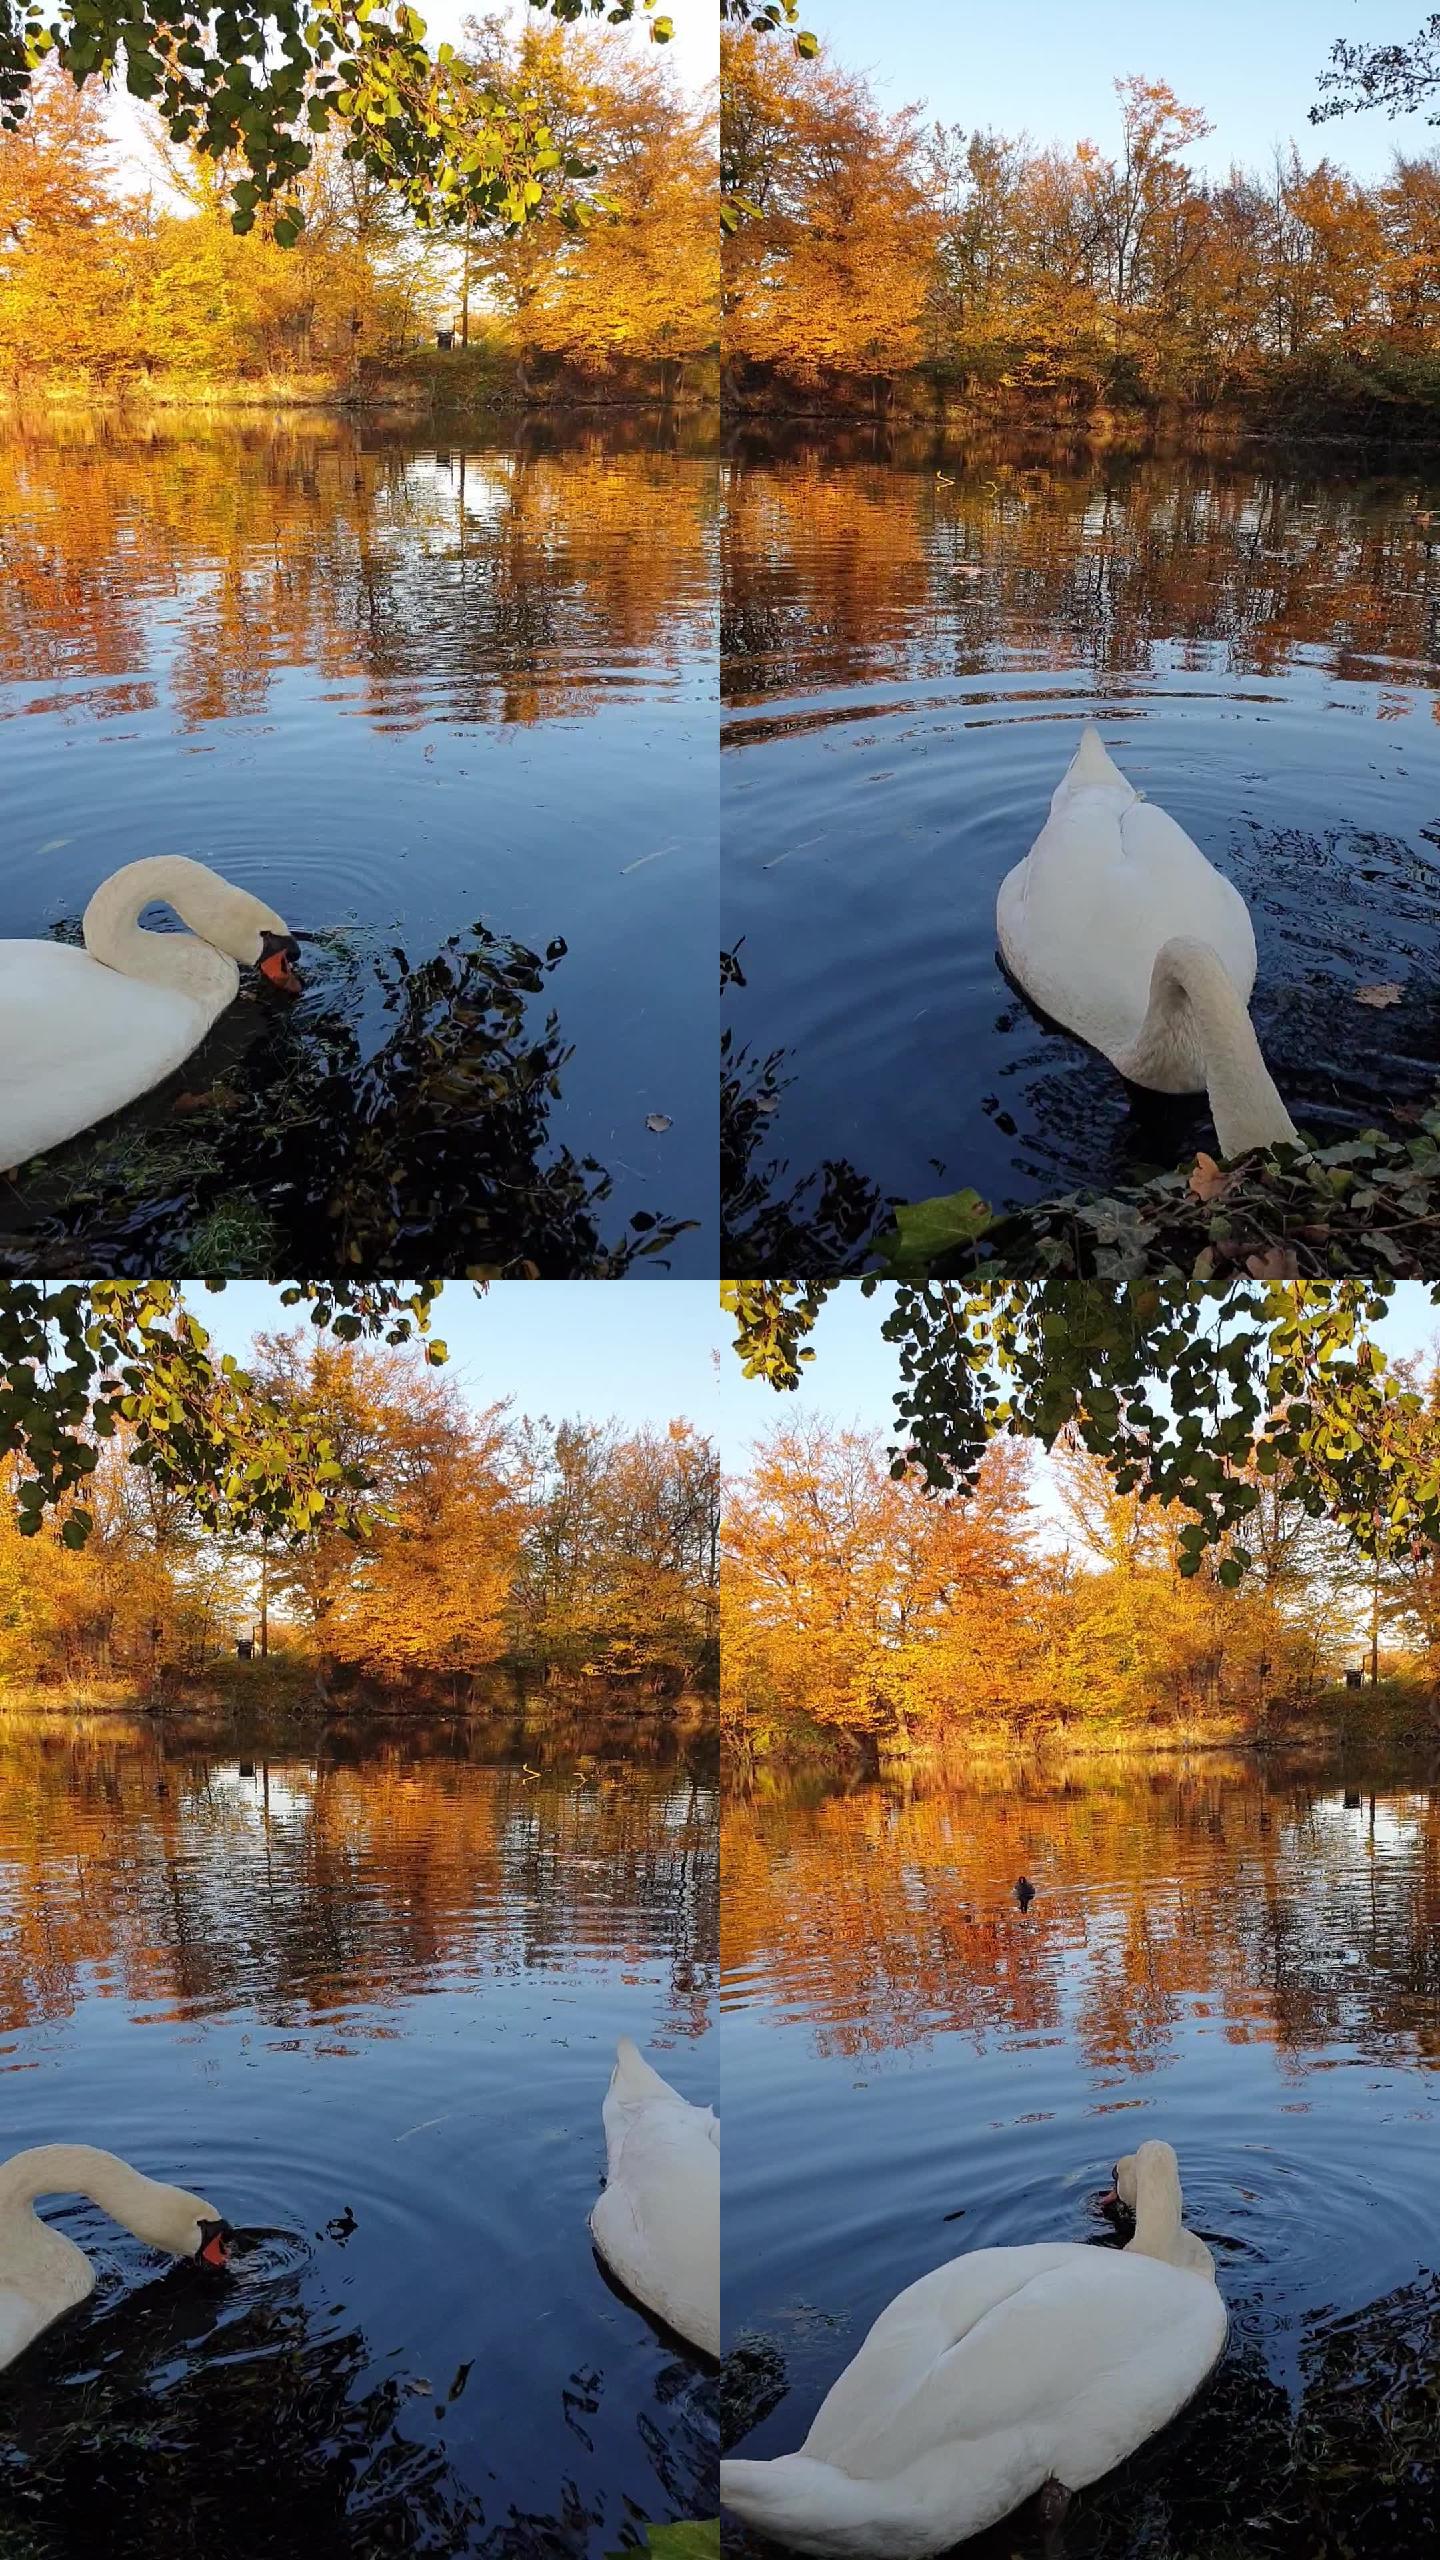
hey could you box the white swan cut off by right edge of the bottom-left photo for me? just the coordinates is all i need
[589,2035,720,2355]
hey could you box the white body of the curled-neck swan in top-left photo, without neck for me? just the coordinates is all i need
[0,942,205,1165]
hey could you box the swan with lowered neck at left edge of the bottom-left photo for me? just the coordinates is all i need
[0,2143,231,2368]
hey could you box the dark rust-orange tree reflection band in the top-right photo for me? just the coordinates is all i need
[725,453,1440,701]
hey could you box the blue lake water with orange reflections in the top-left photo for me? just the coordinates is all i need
[0,415,717,1275]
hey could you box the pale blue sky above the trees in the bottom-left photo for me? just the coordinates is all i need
[184,1280,717,1428]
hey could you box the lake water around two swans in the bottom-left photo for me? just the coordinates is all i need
[0,1718,717,2560]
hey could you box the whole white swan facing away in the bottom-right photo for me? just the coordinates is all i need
[720,2143,1227,2560]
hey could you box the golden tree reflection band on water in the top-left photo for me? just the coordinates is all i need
[0,422,712,730]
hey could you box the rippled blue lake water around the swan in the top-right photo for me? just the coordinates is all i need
[723,443,1440,1267]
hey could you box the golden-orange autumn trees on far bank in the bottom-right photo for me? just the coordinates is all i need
[720,1413,1440,1779]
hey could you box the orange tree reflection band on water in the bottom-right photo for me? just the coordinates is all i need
[723,1761,1440,2074]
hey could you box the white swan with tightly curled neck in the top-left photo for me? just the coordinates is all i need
[0,852,300,1167]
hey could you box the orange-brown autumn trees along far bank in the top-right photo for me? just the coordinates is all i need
[720,31,1440,443]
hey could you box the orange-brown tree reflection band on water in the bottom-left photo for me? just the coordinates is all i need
[0,1720,715,2038]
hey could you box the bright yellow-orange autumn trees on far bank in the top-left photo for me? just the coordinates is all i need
[0,15,717,415]
